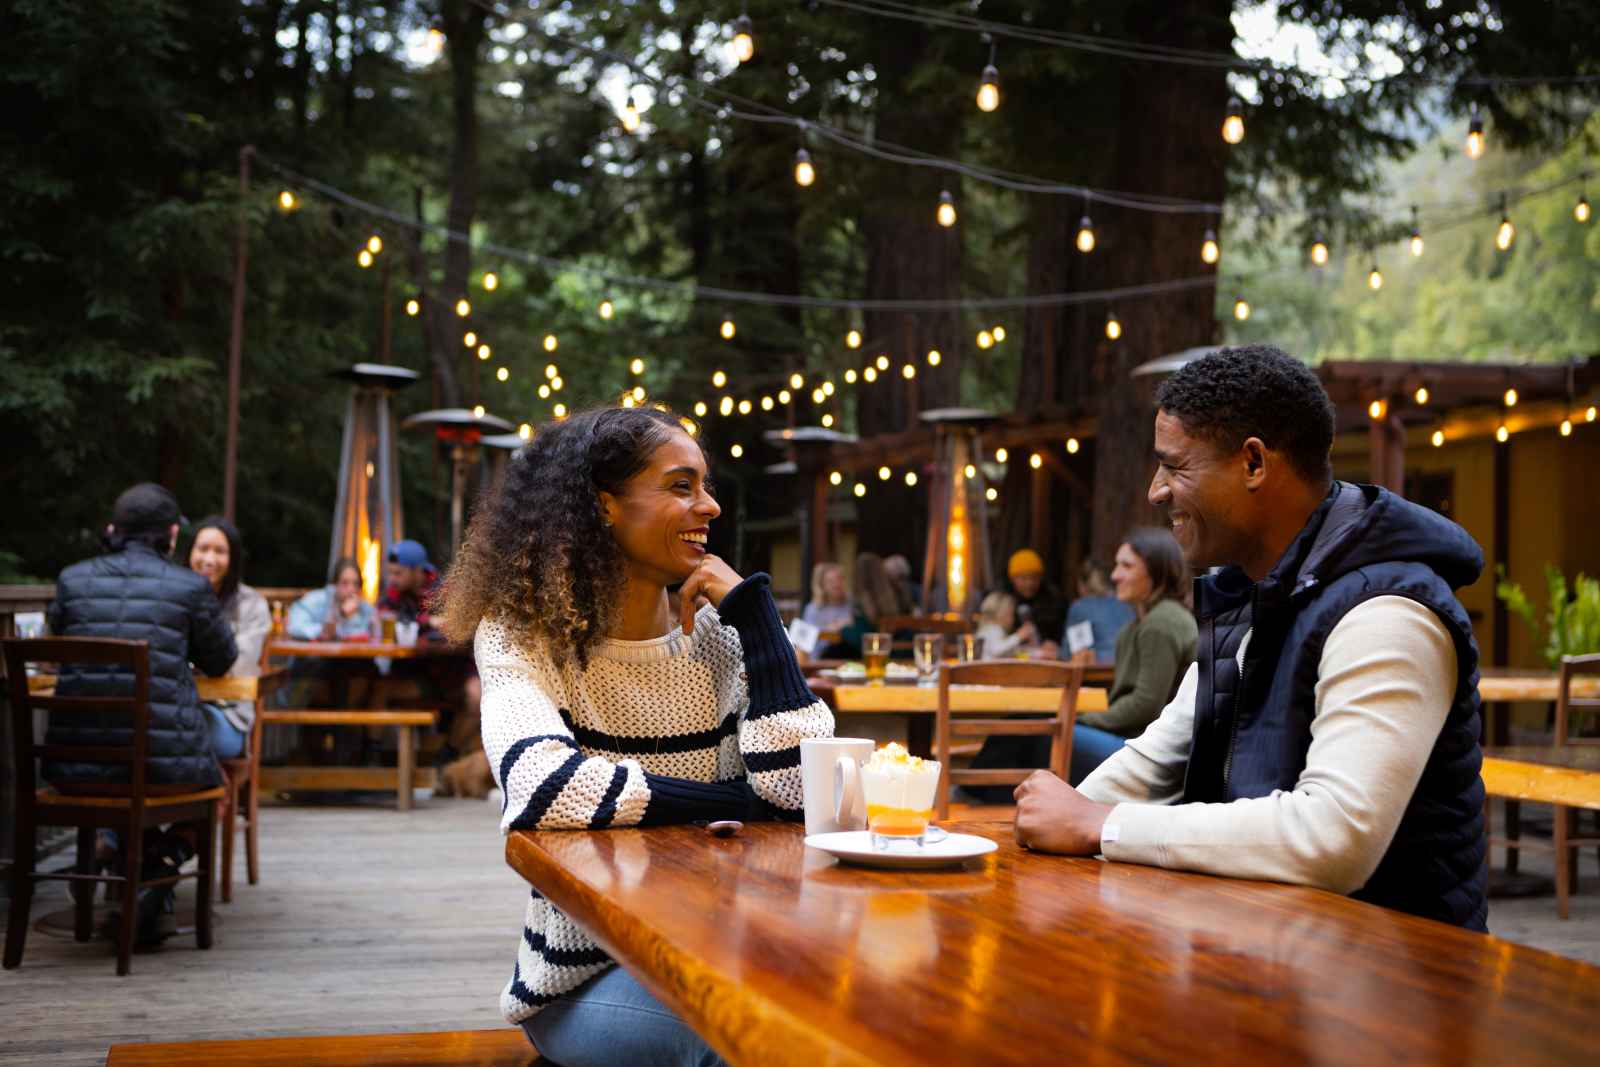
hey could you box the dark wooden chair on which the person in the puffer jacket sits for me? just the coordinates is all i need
[3,638,222,974]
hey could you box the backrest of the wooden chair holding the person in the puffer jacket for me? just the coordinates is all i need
[0,637,150,813]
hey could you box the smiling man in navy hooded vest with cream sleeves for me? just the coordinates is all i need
[1016,346,1488,929]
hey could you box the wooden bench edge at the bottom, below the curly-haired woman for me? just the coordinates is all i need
[106,1027,539,1067]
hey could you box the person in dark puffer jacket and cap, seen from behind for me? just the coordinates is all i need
[43,483,238,792]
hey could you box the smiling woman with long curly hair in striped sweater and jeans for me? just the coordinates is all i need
[443,408,834,1067]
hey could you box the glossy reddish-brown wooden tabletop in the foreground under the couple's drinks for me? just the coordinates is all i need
[506,822,1600,1067]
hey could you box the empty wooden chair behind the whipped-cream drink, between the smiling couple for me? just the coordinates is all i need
[933,659,1083,819]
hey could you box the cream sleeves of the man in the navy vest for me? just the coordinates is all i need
[1082,597,1456,893]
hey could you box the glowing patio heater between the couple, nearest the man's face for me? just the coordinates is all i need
[922,408,995,617]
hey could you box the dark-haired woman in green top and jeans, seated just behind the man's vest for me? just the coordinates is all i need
[1070,526,1200,785]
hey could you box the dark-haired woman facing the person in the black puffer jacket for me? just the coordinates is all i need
[189,515,272,760]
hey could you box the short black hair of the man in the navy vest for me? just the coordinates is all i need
[1155,344,1334,485]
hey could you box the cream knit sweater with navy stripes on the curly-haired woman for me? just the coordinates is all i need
[475,574,834,1024]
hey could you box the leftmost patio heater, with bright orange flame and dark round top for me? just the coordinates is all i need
[328,363,419,601]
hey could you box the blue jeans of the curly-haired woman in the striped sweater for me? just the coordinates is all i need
[522,966,725,1067]
